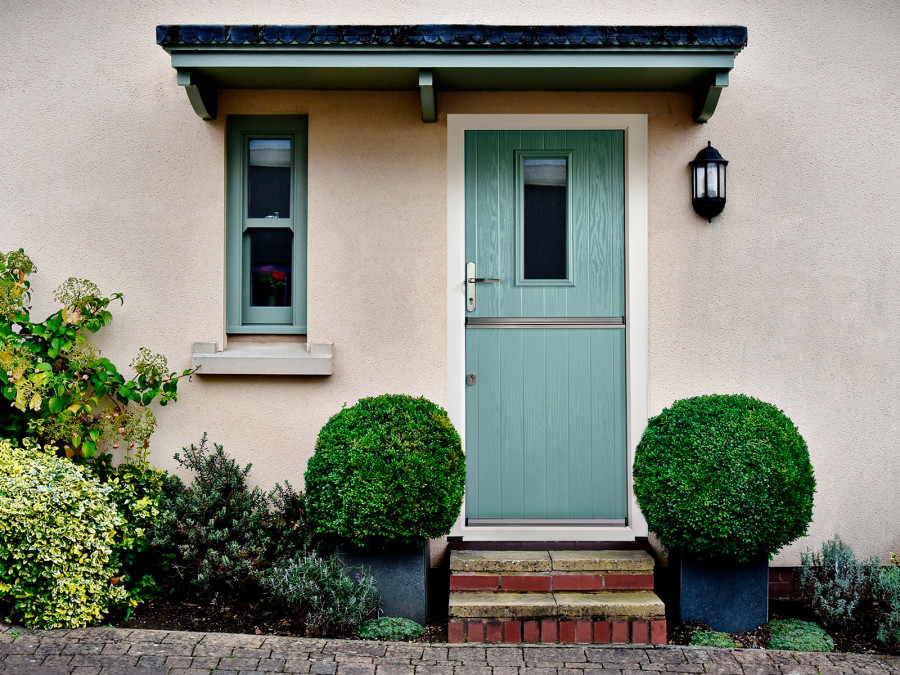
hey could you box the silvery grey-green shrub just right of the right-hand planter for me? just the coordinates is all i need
[797,536,878,628]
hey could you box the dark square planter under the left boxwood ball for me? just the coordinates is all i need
[337,545,429,626]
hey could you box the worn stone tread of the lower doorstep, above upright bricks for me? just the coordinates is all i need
[449,591,666,619]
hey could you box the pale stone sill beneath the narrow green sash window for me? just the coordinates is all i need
[191,342,334,375]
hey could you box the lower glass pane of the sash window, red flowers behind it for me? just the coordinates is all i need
[247,227,294,307]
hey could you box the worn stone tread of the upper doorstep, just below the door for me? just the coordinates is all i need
[450,551,654,574]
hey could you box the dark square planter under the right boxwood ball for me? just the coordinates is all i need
[669,553,769,633]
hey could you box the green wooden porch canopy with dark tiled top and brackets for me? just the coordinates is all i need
[156,25,747,122]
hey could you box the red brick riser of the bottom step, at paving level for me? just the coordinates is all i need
[447,619,666,645]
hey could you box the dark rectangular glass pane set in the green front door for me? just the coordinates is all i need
[522,157,567,279]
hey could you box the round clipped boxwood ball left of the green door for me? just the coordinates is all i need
[306,395,466,548]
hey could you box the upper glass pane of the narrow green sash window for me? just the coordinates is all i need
[247,139,291,218]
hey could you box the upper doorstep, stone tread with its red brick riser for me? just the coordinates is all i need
[450,551,653,592]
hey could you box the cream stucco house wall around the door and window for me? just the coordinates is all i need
[0,0,900,564]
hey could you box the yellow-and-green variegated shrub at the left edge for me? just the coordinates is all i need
[0,440,125,628]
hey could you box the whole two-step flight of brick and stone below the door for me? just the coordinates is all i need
[448,550,666,644]
